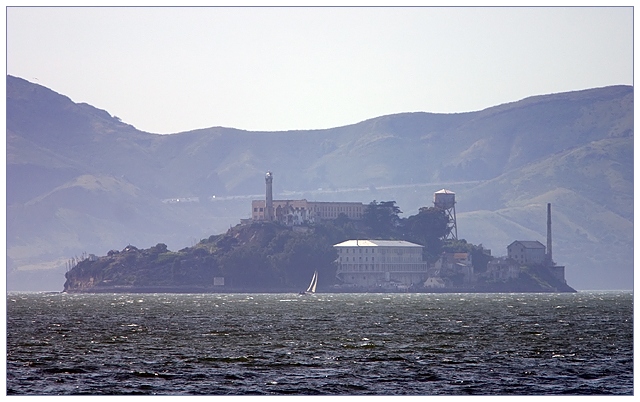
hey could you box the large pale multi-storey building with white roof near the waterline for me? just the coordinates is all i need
[333,240,429,287]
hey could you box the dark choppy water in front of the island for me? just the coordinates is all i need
[6,292,633,395]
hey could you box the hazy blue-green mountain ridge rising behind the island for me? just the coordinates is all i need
[7,76,633,290]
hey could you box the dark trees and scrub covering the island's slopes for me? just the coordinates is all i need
[64,201,576,292]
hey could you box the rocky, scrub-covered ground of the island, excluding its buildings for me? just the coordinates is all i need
[63,204,575,293]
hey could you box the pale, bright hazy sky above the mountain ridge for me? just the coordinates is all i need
[6,7,633,133]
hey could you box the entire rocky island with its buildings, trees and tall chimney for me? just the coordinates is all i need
[63,198,575,293]
